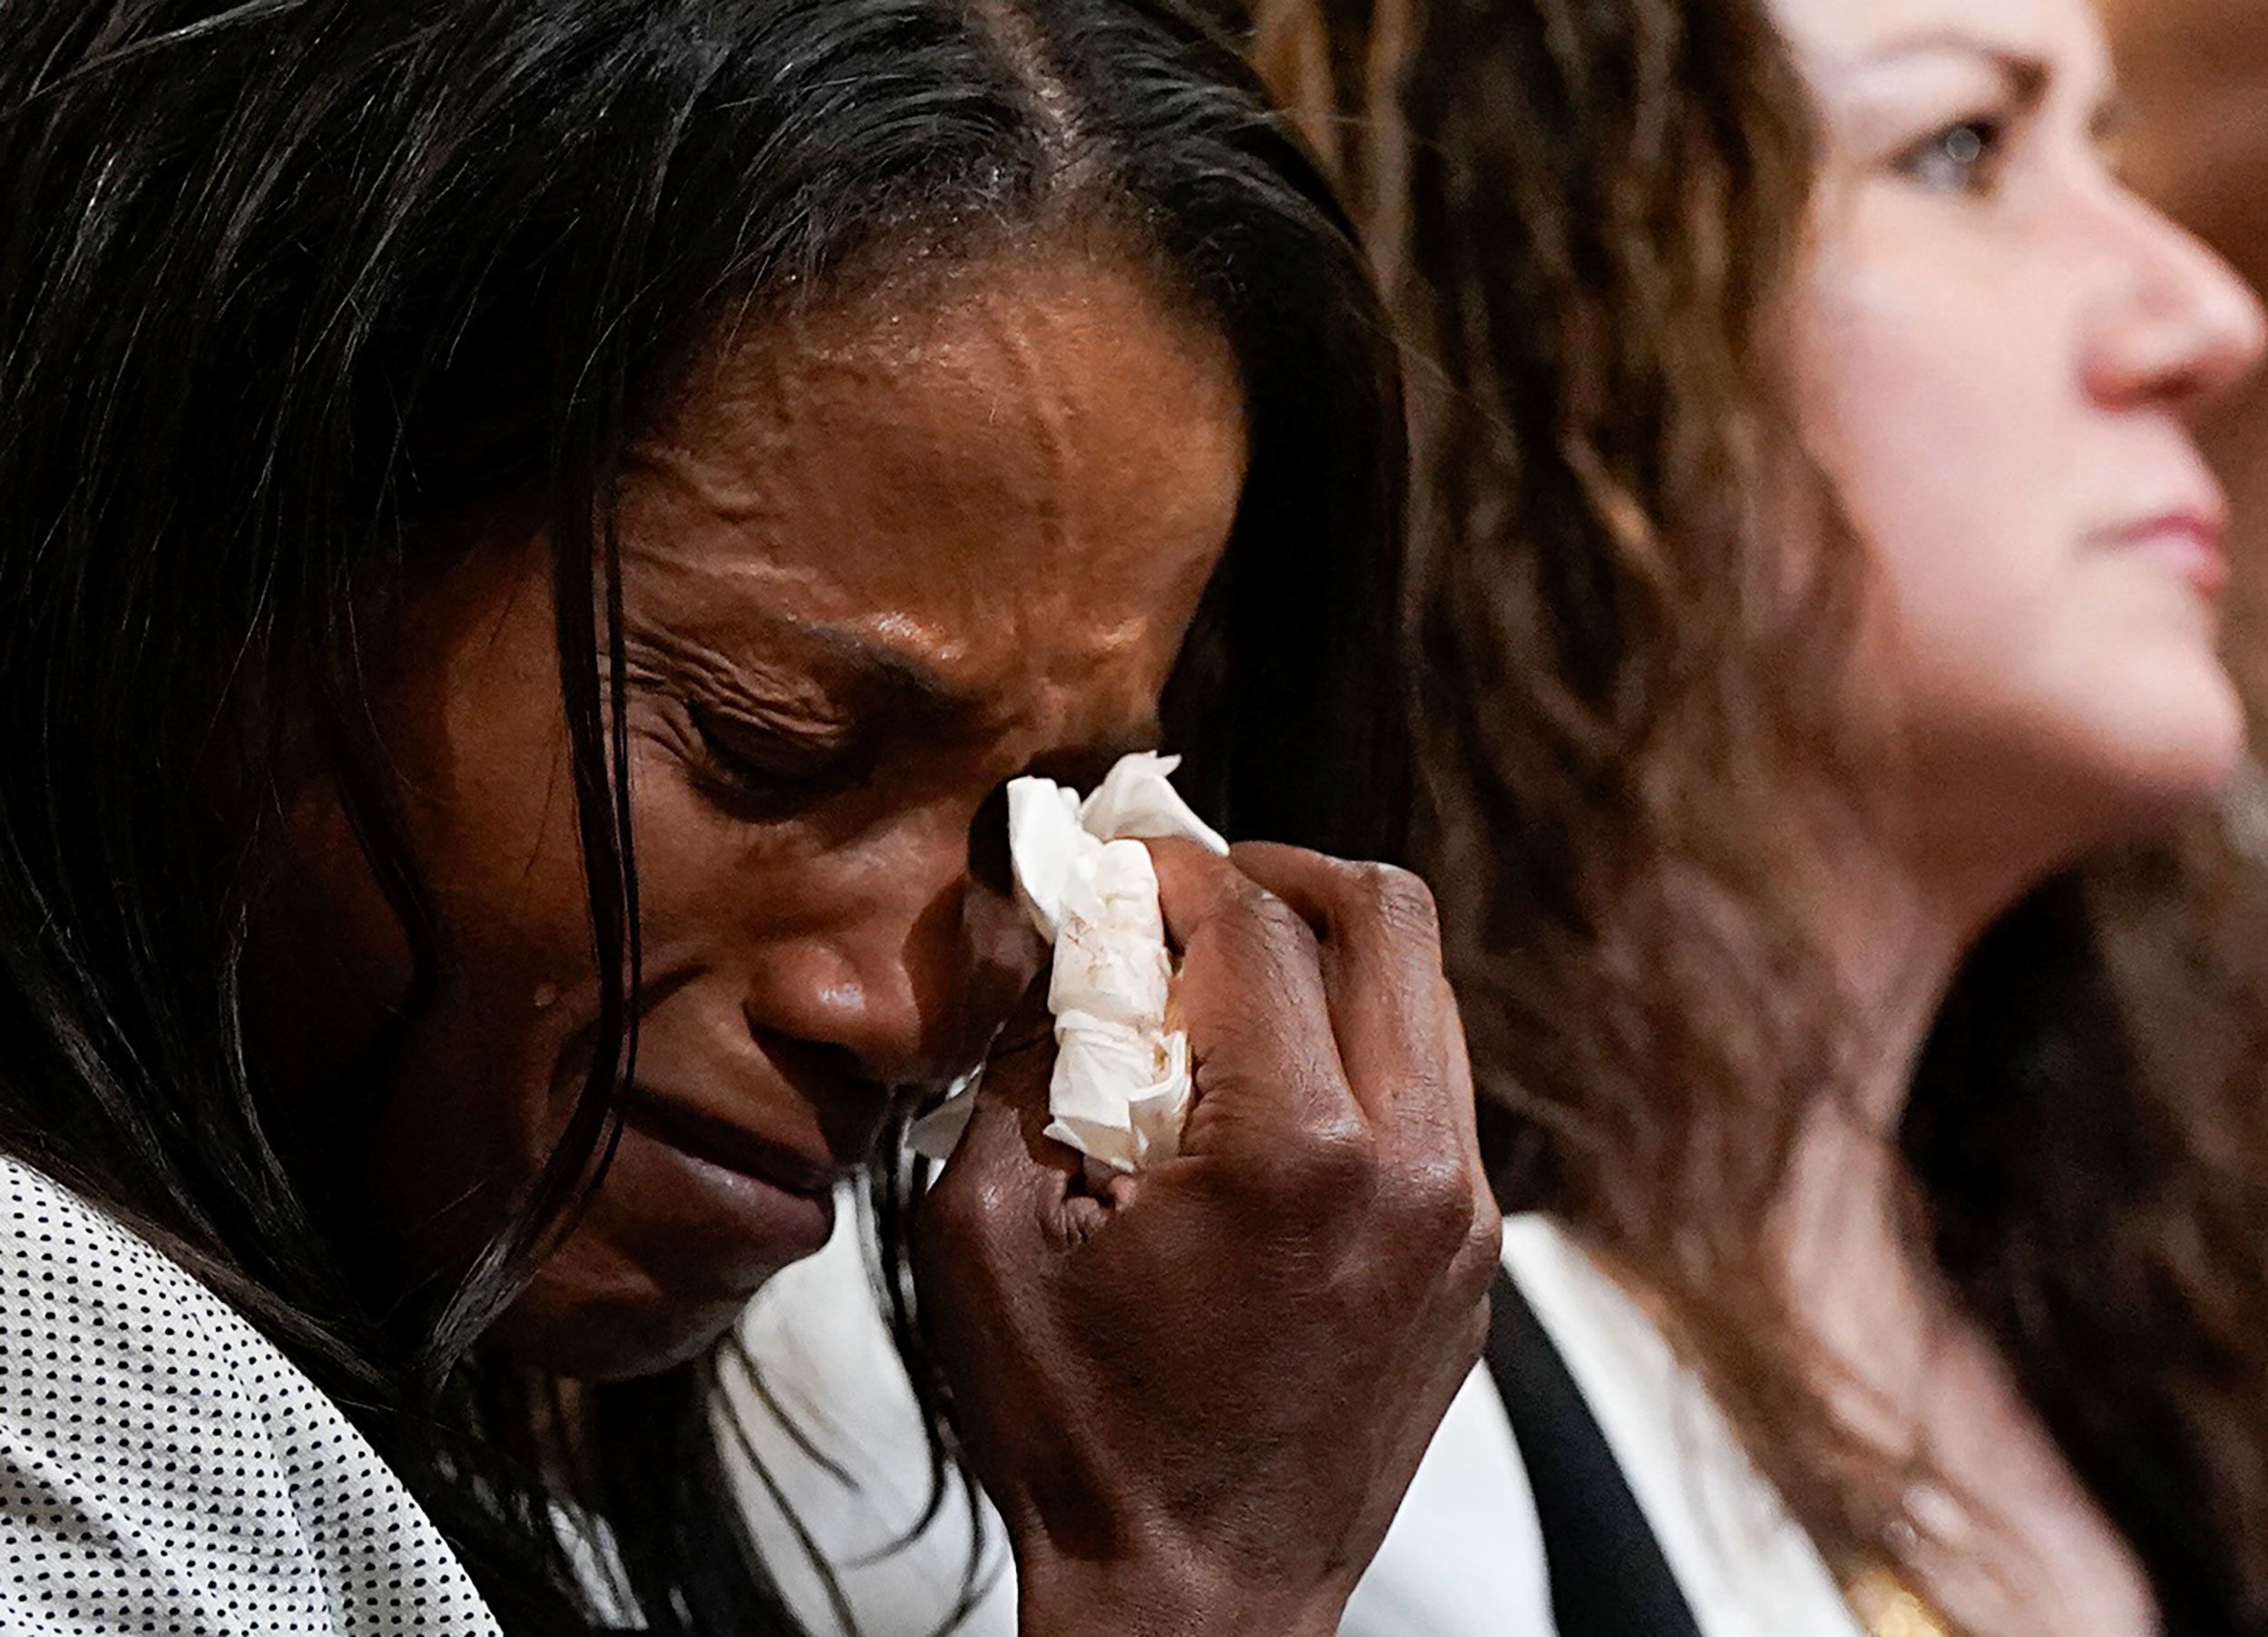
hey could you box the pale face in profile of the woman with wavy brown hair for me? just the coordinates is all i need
[1776,0,2262,891]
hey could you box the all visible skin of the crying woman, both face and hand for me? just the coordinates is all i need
[248,235,1497,1637]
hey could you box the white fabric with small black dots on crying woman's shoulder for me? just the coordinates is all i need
[0,1159,497,1637]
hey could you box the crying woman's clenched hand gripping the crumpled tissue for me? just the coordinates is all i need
[914,843,1500,1637]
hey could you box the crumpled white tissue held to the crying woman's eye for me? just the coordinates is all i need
[912,750,1229,1172]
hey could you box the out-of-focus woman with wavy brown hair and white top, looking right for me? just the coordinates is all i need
[1356,0,2268,1637]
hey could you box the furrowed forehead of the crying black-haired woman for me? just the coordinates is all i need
[621,248,1246,716]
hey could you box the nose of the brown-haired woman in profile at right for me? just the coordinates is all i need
[2087,195,2268,413]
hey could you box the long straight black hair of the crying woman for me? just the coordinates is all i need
[0,0,1402,1637]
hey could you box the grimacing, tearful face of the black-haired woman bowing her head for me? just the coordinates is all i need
[268,251,1246,1377]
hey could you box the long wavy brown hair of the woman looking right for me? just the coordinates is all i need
[1247,0,2268,1632]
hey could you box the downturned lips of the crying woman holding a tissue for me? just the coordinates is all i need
[621,1088,848,1265]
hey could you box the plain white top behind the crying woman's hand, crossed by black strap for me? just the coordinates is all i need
[733,1209,1860,1637]
